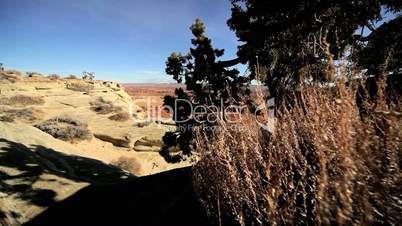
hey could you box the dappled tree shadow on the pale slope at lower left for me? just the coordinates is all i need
[0,138,135,222]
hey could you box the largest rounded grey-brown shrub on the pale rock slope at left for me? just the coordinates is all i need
[35,117,92,141]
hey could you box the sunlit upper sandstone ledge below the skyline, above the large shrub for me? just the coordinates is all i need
[0,74,164,150]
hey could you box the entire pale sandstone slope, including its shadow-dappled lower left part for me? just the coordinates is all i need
[0,71,190,225]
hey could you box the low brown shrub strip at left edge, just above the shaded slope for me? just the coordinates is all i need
[0,108,44,122]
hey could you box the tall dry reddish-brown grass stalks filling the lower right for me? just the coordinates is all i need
[193,82,402,225]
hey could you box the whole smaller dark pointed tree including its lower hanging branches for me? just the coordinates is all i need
[161,18,250,161]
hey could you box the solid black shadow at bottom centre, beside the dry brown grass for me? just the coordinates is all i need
[25,168,211,226]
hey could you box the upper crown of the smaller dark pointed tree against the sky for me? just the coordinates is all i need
[166,18,250,104]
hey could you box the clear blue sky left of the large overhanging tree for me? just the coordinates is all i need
[0,0,242,82]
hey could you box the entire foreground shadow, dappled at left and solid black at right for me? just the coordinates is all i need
[0,138,210,226]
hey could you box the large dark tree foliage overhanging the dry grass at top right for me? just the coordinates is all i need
[228,0,402,101]
